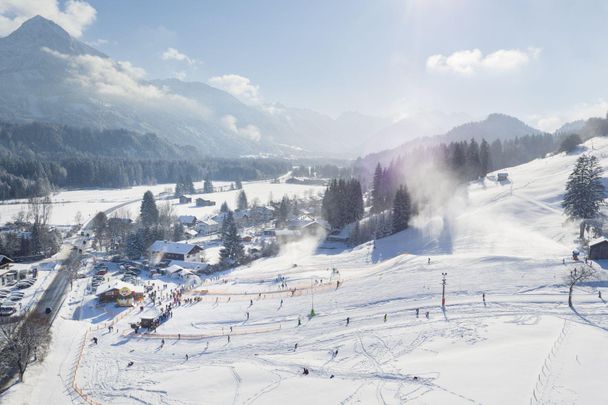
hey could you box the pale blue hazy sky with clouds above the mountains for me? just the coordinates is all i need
[0,0,608,130]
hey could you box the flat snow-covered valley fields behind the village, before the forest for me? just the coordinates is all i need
[0,181,323,225]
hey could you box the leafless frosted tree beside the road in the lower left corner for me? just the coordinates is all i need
[0,314,50,381]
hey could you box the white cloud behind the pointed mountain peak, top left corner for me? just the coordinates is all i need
[0,0,97,38]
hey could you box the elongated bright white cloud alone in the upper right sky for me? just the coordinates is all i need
[426,48,540,75]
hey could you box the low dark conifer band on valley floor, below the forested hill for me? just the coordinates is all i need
[0,158,290,200]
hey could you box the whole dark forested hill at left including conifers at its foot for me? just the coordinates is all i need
[0,123,291,200]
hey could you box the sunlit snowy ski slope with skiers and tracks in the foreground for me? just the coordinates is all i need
[0,138,608,404]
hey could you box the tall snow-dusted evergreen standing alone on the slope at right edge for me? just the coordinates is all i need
[562,155,606,219]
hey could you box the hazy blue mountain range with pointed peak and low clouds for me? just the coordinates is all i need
[0,16,600,161]
